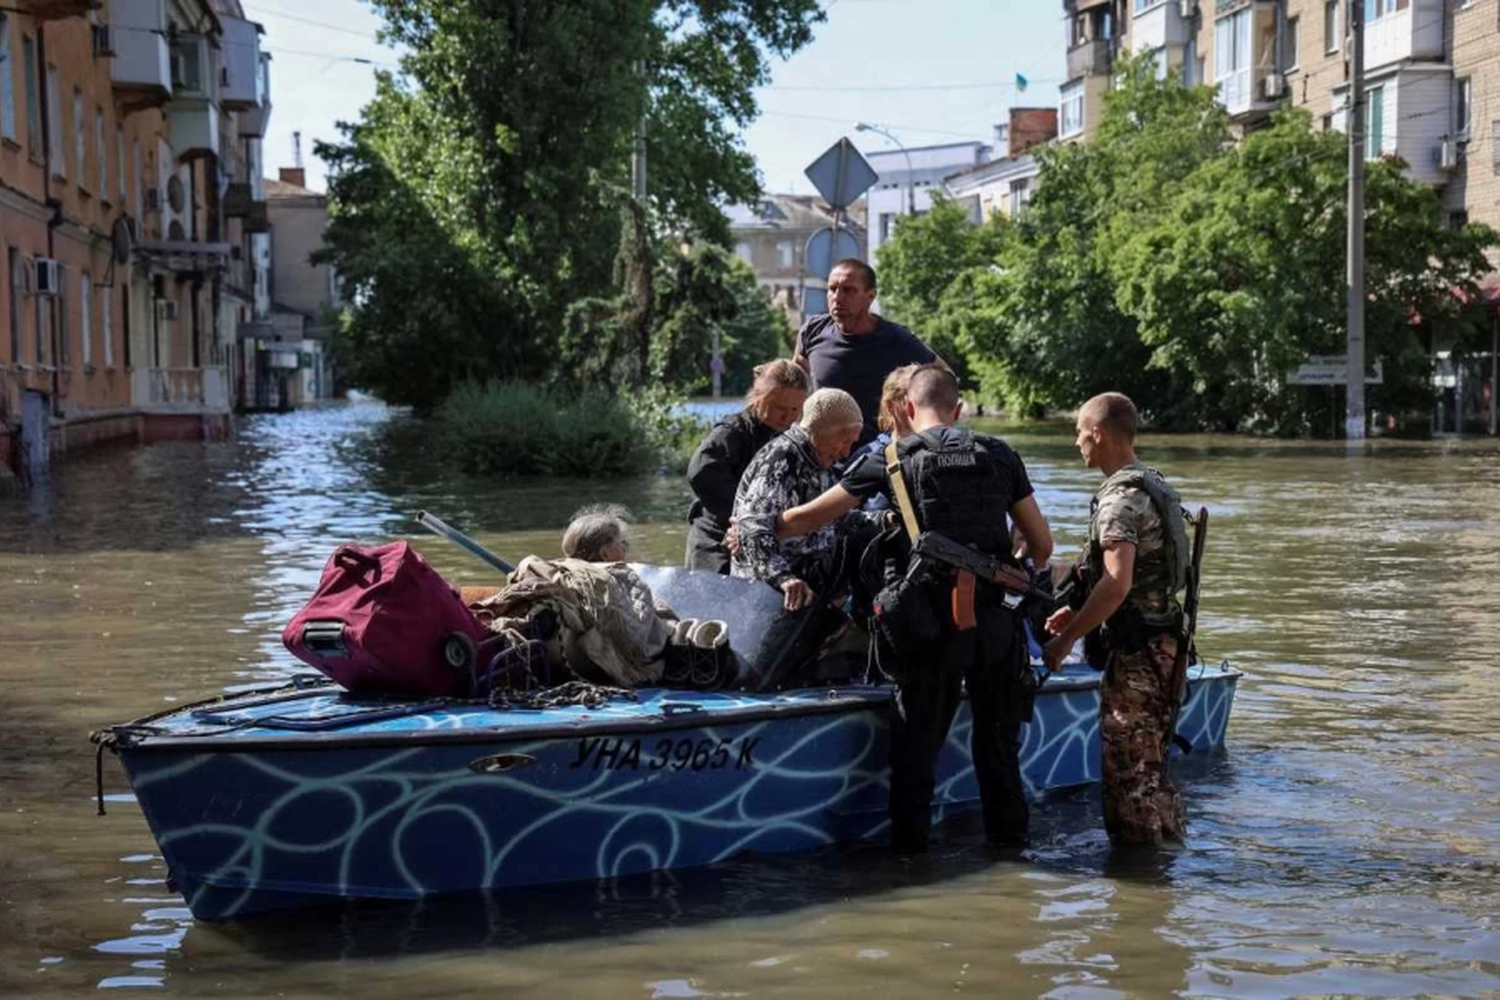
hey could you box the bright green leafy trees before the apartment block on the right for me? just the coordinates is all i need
[882,58,1500,433]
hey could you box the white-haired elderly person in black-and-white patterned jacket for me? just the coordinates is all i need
[729,388,864,610]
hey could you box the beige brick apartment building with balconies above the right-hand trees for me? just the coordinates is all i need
[1059,0,1500,248]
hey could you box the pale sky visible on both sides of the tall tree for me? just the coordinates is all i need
[245,0,1065,193]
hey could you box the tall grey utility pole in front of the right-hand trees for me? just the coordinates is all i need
[1344,0,1370,441]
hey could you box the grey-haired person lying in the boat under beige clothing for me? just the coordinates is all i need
[476,504,677,688]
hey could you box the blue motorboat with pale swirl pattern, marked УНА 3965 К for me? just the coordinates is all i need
[96,567,1239,919]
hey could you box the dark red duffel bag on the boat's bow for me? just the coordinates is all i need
[282,541,491,696]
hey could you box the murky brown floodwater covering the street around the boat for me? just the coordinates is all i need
[0,403,1500,1000]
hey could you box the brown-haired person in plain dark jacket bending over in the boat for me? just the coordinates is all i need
[684,358,807,574]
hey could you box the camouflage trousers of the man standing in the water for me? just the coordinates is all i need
[1100,633,1187,844]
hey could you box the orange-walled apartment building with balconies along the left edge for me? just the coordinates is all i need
[0,0,270,475]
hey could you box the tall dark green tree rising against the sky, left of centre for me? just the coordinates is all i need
[318,0,822,408]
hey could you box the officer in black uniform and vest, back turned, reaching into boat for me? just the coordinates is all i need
[777,363,1052,855]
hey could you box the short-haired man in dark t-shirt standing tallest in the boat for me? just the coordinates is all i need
[792,259,938,447]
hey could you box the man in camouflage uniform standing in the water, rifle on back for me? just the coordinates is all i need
[1043,393,1190,844]
